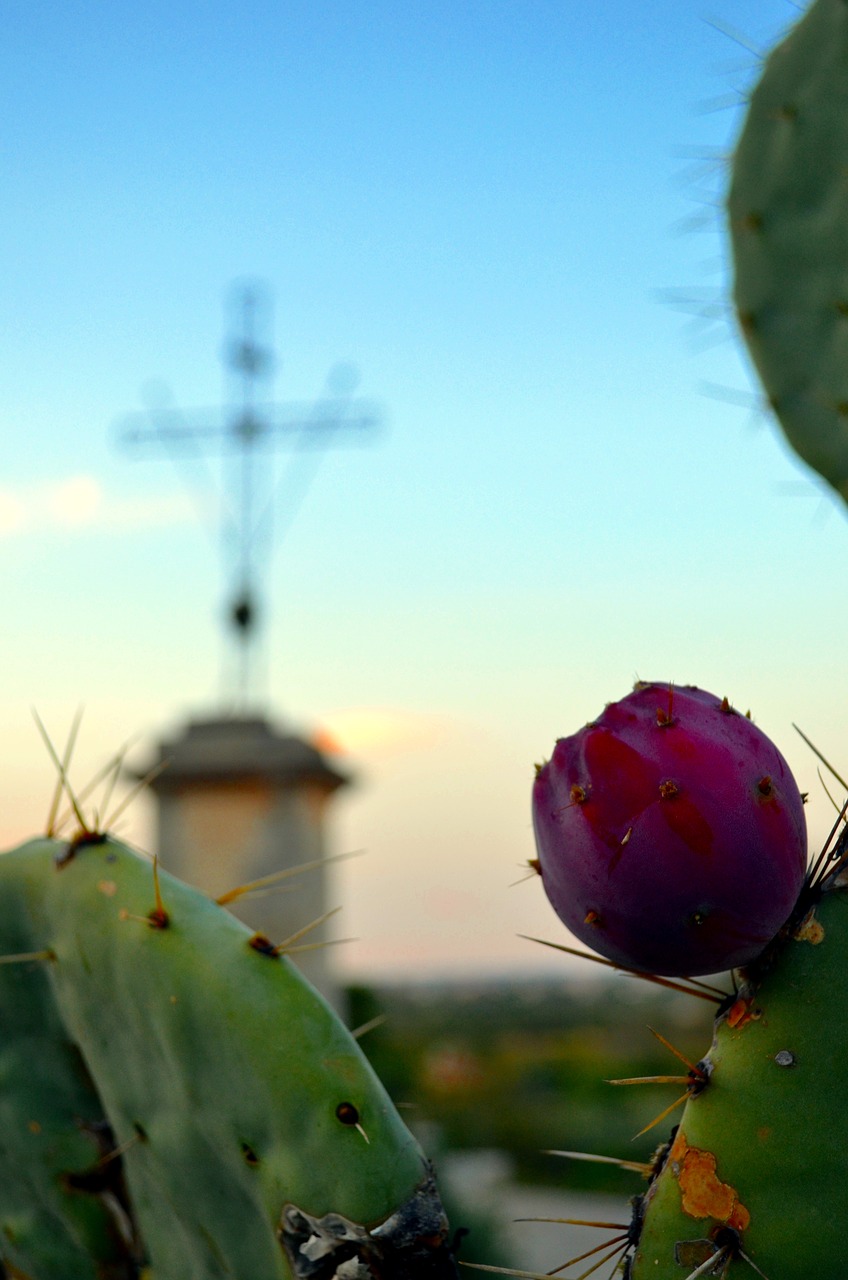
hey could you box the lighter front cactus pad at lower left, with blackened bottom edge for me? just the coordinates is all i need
[0,837,452,1280]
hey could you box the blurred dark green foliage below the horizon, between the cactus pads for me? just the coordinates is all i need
[351,978,708,1196]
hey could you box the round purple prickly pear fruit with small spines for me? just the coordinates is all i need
[533,684,807,975]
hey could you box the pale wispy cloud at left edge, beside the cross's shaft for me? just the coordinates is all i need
[0,472,197,538]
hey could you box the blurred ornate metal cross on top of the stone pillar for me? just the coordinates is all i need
[118,285,380,708]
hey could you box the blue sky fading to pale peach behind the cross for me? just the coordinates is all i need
[0,0,848,979]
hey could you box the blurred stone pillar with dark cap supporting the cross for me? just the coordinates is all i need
[138,717,350,1007]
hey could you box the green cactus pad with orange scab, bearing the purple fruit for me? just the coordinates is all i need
[632,890,848,1280]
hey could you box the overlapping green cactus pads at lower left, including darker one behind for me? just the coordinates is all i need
[0,832,455,1280]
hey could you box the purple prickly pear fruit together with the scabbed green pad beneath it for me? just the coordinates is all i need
[533,685,848,1280]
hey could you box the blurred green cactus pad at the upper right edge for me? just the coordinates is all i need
[729,0,848,500]
